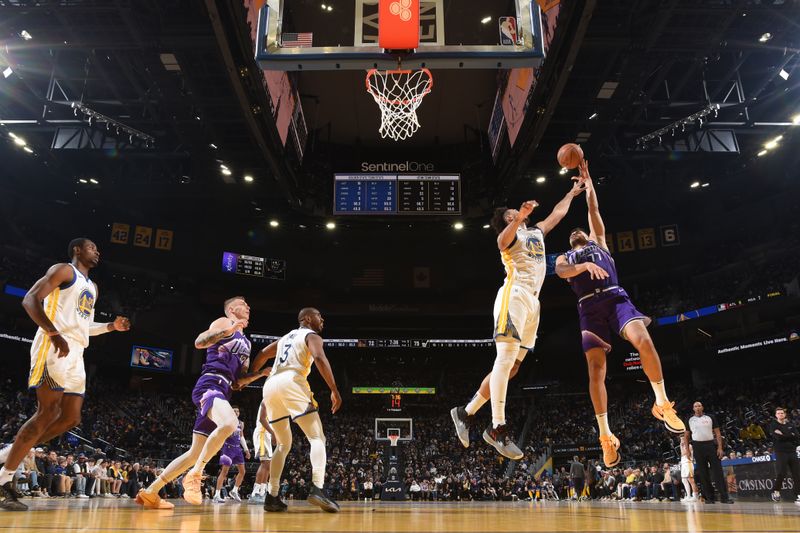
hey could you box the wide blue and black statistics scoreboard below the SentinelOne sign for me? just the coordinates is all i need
[333,174,461,215]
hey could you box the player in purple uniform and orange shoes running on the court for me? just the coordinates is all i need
[136,296,271,509]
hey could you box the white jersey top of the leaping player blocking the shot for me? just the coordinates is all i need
[500,226,547,295]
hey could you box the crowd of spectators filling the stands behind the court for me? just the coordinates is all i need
[0,370,800,501]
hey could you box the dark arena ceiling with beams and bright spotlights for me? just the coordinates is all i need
[0,0,800,219]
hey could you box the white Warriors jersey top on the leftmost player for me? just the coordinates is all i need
[44,264,97,348]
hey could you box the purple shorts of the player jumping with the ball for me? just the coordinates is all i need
[578,287,650,352]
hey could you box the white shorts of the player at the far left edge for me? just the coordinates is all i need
[28,329,86,396]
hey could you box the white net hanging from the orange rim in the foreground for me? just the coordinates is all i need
[367,68,433,141]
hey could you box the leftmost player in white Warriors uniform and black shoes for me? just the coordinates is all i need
[0,238,130,511]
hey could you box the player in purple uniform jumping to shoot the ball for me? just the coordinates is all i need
[556,161,685,467]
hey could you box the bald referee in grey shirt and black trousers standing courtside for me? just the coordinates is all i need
[683,402,733,503]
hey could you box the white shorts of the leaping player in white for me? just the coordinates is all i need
[494,283,541,360]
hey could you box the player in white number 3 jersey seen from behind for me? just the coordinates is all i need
[262,307,342,513]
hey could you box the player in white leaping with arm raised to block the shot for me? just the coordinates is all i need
[450,179,584,460]
